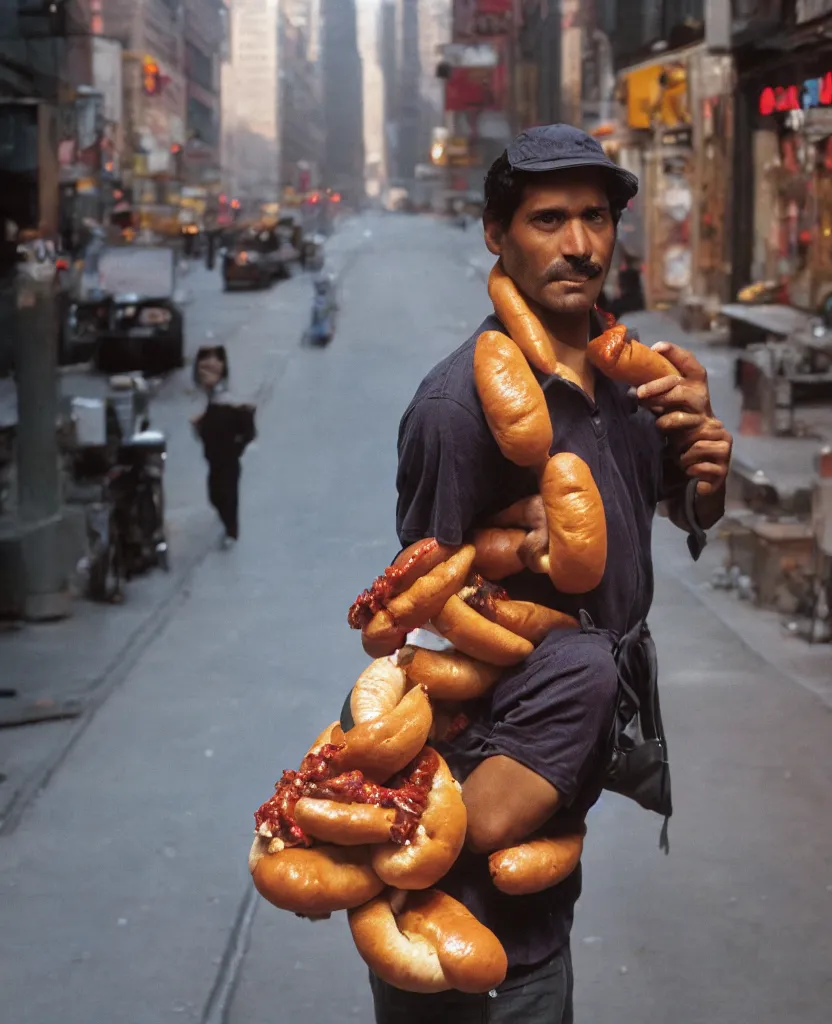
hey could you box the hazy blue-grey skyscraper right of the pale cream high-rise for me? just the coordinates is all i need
[321,0,364,200]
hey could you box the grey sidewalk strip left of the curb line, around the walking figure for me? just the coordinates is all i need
[0,232,366,834]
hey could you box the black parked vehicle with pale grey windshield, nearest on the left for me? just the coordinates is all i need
[69,246,184,373]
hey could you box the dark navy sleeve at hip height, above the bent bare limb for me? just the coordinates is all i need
[484,633,618,807]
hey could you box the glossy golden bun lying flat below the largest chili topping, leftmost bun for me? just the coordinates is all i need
[249,836,384,914]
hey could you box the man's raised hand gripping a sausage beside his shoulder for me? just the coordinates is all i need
[636,341,733,501]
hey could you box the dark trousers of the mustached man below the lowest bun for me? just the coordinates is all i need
[370,946,573,1024]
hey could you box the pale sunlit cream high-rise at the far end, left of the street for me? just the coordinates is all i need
[221,0,282,203]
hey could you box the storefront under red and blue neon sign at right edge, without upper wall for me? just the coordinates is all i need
[735,42,832,310]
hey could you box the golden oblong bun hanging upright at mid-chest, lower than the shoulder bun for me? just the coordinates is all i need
[540,452,607,594]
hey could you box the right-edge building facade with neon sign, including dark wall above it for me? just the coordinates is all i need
[731,0,832,310]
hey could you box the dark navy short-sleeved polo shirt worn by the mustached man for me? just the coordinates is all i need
[397,316,683,971]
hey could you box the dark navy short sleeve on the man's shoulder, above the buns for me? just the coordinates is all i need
[396,397,496,546]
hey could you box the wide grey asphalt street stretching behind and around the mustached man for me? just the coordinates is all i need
[0,214,832,1024]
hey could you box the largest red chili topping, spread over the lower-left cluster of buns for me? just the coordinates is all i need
[254,744,439,847]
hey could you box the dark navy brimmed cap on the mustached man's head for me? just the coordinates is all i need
[506,125,638,207]
